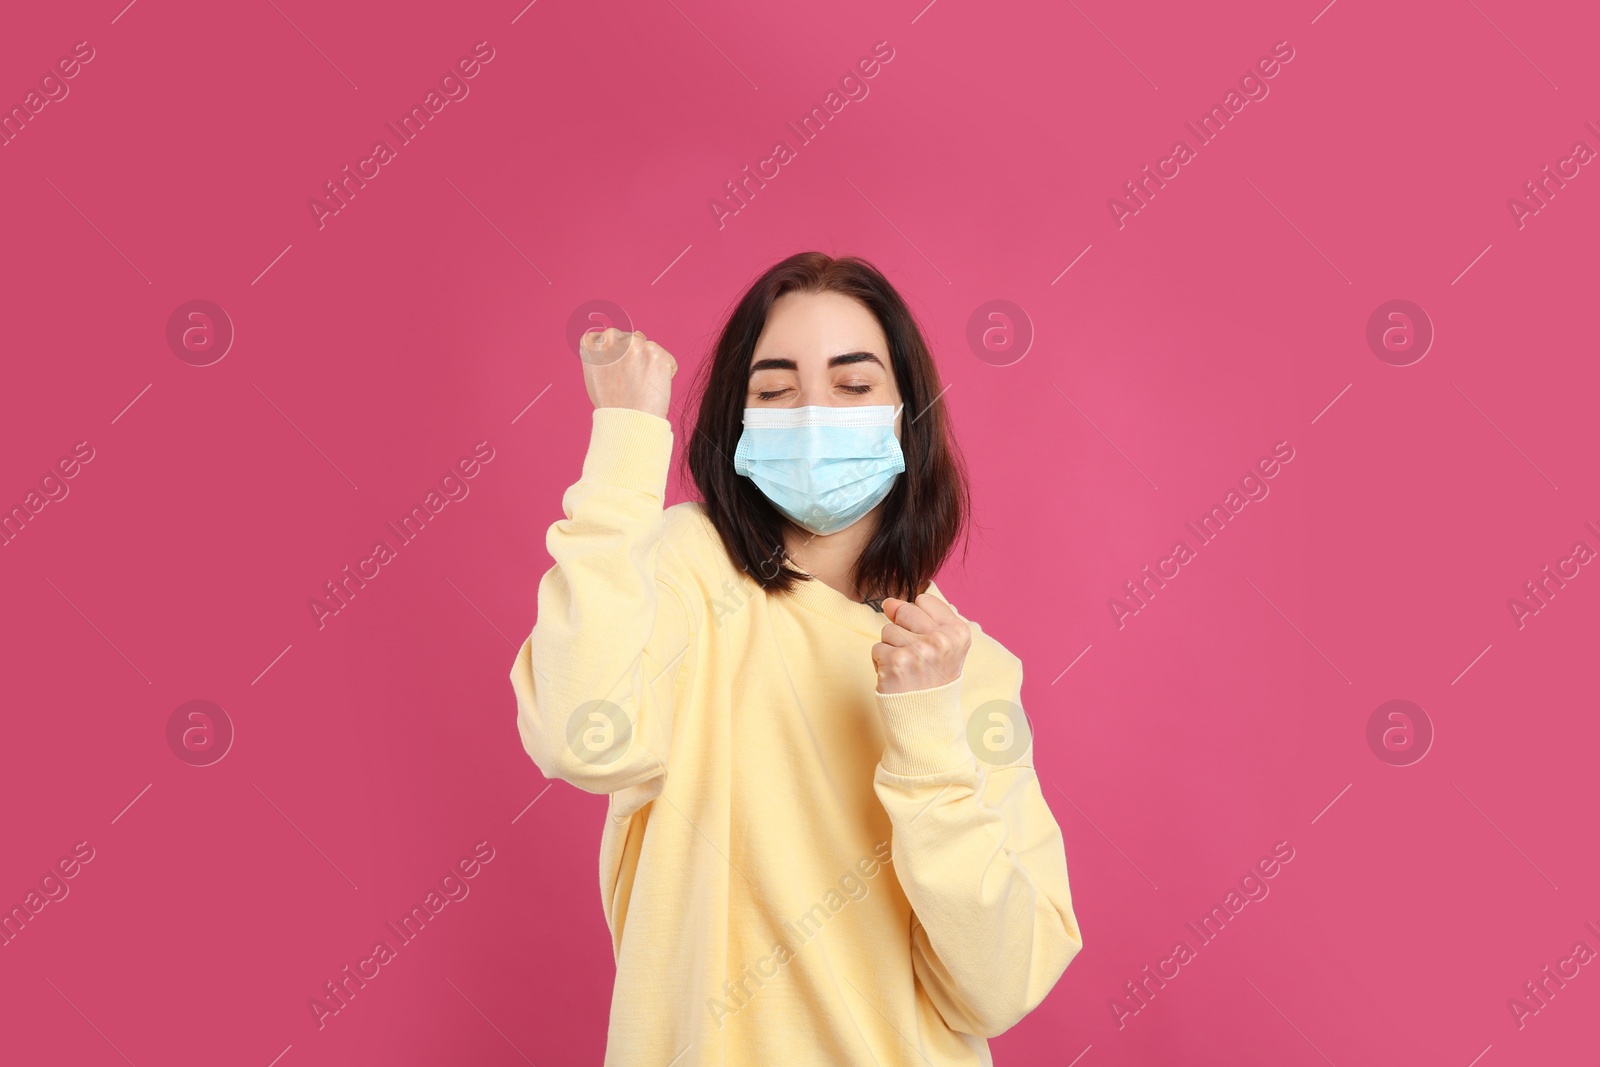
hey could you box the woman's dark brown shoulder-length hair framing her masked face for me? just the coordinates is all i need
[683,251,970,600]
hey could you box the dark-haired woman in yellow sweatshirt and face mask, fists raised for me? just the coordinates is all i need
[510,253,1083,1067]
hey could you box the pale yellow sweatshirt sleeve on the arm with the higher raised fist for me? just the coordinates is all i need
[510,408,693,814]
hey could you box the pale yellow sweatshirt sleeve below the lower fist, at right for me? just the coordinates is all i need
[874,638,1083,1038]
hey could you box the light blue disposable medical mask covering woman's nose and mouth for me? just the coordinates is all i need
[733,403,906,534]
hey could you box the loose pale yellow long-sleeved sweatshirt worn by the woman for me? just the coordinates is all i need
[510,408,1083,1067]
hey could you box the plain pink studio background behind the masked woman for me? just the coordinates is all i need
[0,0,1600,1067]
